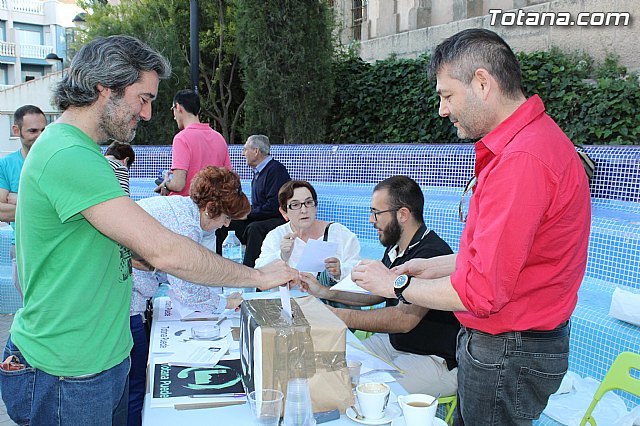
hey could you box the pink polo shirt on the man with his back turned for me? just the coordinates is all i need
[171,123,231,196]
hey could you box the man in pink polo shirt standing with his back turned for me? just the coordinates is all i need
[156,89,231,196]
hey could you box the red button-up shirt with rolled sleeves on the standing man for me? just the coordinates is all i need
[451,96,591,334]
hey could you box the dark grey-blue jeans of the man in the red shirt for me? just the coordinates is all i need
[454,323,570,426]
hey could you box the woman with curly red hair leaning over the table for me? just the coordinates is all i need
[128,166,251,426]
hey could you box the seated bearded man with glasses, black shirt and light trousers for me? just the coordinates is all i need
[300,176,460,395]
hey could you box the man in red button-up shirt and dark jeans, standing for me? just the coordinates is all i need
[352,29,591,425]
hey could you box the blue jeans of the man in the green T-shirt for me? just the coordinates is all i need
[0,336,130,426]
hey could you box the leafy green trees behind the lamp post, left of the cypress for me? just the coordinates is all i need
[75,0,244,145]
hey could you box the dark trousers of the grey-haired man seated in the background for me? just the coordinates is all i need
[216,217,285,268]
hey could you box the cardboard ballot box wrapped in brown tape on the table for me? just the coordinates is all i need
[240,296,354,413]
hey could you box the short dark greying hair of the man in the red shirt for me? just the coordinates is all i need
[429,28,523,99]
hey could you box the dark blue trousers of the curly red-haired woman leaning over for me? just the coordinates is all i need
[127,315,149,426]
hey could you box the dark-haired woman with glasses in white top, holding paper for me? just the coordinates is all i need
[256,180,360,296]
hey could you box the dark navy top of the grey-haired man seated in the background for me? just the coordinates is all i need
[247,159,291,221]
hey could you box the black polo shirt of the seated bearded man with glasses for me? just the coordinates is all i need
[382,225,460,370]
